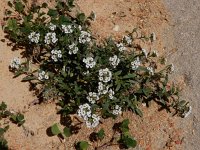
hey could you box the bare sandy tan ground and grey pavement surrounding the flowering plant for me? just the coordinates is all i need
[0,0,200,150]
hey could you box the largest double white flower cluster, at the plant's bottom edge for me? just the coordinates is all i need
[78,103,100,128]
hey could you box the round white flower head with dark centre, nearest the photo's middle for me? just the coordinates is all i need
[99,68,112,83]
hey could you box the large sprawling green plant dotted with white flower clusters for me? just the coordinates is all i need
[4,0,189,149]
